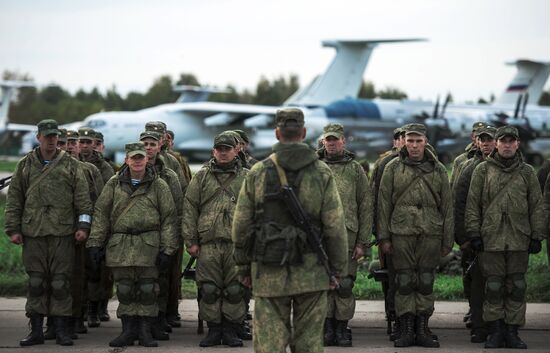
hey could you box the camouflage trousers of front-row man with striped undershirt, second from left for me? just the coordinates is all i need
[111,266,159,318]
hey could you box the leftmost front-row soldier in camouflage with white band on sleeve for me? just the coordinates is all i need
[5,119,92,346]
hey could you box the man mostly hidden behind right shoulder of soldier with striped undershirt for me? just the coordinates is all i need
[139,131,187,340]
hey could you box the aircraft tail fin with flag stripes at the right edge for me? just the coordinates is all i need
[495,59,550,104]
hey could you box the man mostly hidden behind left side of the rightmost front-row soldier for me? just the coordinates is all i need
[453,126,497,343]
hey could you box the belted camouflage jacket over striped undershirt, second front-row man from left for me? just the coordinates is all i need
[86,166,178,267]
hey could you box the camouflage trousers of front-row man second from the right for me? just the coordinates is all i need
[392,235,441,316]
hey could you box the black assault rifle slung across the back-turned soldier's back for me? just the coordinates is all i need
[281,185,339,288]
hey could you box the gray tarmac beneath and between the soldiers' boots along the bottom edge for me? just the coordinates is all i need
[0,298,550,353]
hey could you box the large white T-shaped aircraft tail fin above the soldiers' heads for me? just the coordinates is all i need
[284,38,425,107]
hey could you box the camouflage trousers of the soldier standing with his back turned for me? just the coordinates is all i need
[254,291,327,353]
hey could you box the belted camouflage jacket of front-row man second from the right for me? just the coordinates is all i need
[377,147,454,248]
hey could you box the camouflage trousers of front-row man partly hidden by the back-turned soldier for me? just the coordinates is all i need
[327,253,357,321]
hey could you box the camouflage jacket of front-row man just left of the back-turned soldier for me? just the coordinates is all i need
[182,159,248,247]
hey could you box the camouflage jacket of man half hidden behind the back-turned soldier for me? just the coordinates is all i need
[318,149,373,251]
